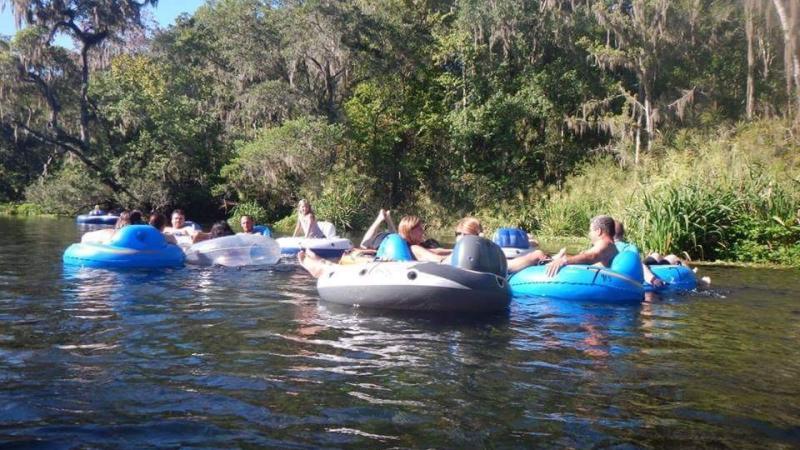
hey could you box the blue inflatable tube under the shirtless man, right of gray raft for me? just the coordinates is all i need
[508,252,644,303]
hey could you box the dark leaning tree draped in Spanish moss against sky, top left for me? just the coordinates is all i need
[0,0,157,200]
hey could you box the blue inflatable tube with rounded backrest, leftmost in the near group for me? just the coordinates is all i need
[63,225,186,269]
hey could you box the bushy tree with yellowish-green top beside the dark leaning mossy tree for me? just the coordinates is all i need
[92,55,225,214]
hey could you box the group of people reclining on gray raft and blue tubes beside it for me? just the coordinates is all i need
[297,202,681,287]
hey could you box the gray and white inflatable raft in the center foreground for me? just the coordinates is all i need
[317,261,511,312]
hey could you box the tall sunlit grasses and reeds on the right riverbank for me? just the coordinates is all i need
[528,121,800,265]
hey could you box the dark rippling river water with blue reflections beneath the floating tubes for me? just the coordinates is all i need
[0,217,800,448]
